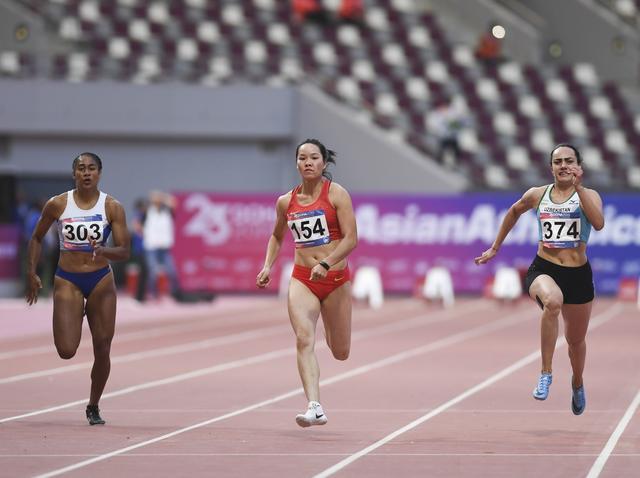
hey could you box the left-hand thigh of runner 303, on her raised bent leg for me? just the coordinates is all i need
[53,276,84,349]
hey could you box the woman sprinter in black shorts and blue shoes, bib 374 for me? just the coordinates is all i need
[475,144,604,415]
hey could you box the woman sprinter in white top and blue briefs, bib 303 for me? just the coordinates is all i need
[26,153,130,425]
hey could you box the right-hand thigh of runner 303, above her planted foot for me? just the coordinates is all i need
[87,272,117,339]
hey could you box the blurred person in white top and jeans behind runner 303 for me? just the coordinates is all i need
[142,191,179,298]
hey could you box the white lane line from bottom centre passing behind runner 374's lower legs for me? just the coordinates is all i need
[313,304,622,478]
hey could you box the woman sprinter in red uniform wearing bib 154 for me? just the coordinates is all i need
[256,139,357,427]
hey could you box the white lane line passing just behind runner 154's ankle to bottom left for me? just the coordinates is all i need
[36,302,538,478]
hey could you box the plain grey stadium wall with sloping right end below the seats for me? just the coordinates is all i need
[0,80,466,212]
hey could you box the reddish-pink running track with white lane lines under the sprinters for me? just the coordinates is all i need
[0,298,640,478]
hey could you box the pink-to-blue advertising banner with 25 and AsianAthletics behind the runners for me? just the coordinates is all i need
[174,193,640,294]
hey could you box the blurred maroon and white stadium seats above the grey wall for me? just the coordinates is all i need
[5,0,640,190]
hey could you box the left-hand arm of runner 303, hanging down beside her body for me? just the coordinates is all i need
[25,196,64,305]
